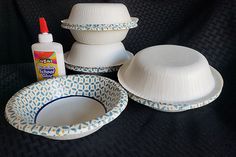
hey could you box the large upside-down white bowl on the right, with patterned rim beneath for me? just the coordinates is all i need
[118,45,223,112]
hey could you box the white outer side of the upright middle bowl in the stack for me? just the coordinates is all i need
[70,29,129,45]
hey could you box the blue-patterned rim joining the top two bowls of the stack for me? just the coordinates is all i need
[61,17,139,31]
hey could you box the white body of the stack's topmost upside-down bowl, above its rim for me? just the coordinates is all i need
[65,3,131,25]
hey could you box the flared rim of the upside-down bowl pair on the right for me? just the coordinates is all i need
[117,62,224,107]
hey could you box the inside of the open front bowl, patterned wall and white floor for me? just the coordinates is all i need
[8,75,122,126]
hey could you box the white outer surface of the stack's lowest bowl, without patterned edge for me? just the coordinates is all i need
[65,42,132,67]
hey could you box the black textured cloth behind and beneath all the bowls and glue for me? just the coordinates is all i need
[0,0,236,157]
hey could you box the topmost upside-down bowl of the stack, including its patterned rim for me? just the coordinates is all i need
[61,3,138,31]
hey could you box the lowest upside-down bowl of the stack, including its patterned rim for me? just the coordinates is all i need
[64,42,133,73]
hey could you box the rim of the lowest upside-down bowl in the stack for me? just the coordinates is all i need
[64,51,133,73]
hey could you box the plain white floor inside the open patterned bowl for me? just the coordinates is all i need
[35,96,106,126]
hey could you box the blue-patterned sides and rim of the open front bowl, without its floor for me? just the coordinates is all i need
[5,75,128,139]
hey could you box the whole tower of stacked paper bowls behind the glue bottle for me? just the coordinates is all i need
[61,3,138,73]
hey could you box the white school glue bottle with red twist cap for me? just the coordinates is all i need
[32,17,66,80]
